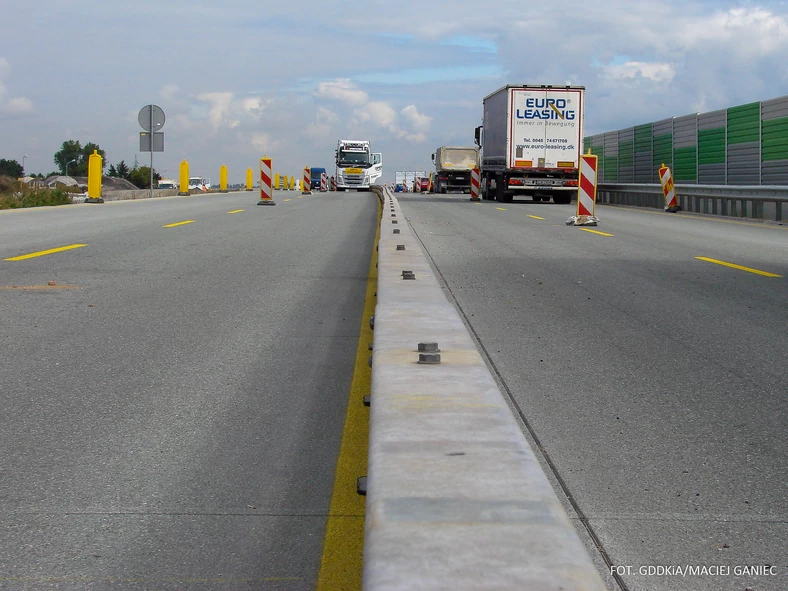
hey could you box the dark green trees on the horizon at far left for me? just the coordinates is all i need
[0,140,161,189]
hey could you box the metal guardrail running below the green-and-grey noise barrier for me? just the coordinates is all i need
[597,183,788,222]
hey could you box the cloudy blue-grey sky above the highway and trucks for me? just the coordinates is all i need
[0,0,788,182]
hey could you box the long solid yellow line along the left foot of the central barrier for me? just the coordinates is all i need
[317,201,383,591]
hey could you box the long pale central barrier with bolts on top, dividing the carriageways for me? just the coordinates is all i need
[366,187,605,591]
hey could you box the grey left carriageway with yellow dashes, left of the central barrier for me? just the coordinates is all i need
[0,192,378,590]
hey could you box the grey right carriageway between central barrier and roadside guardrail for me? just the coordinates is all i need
[397,194,788,591]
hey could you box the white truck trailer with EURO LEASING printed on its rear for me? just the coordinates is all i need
[476,84,585,204]
